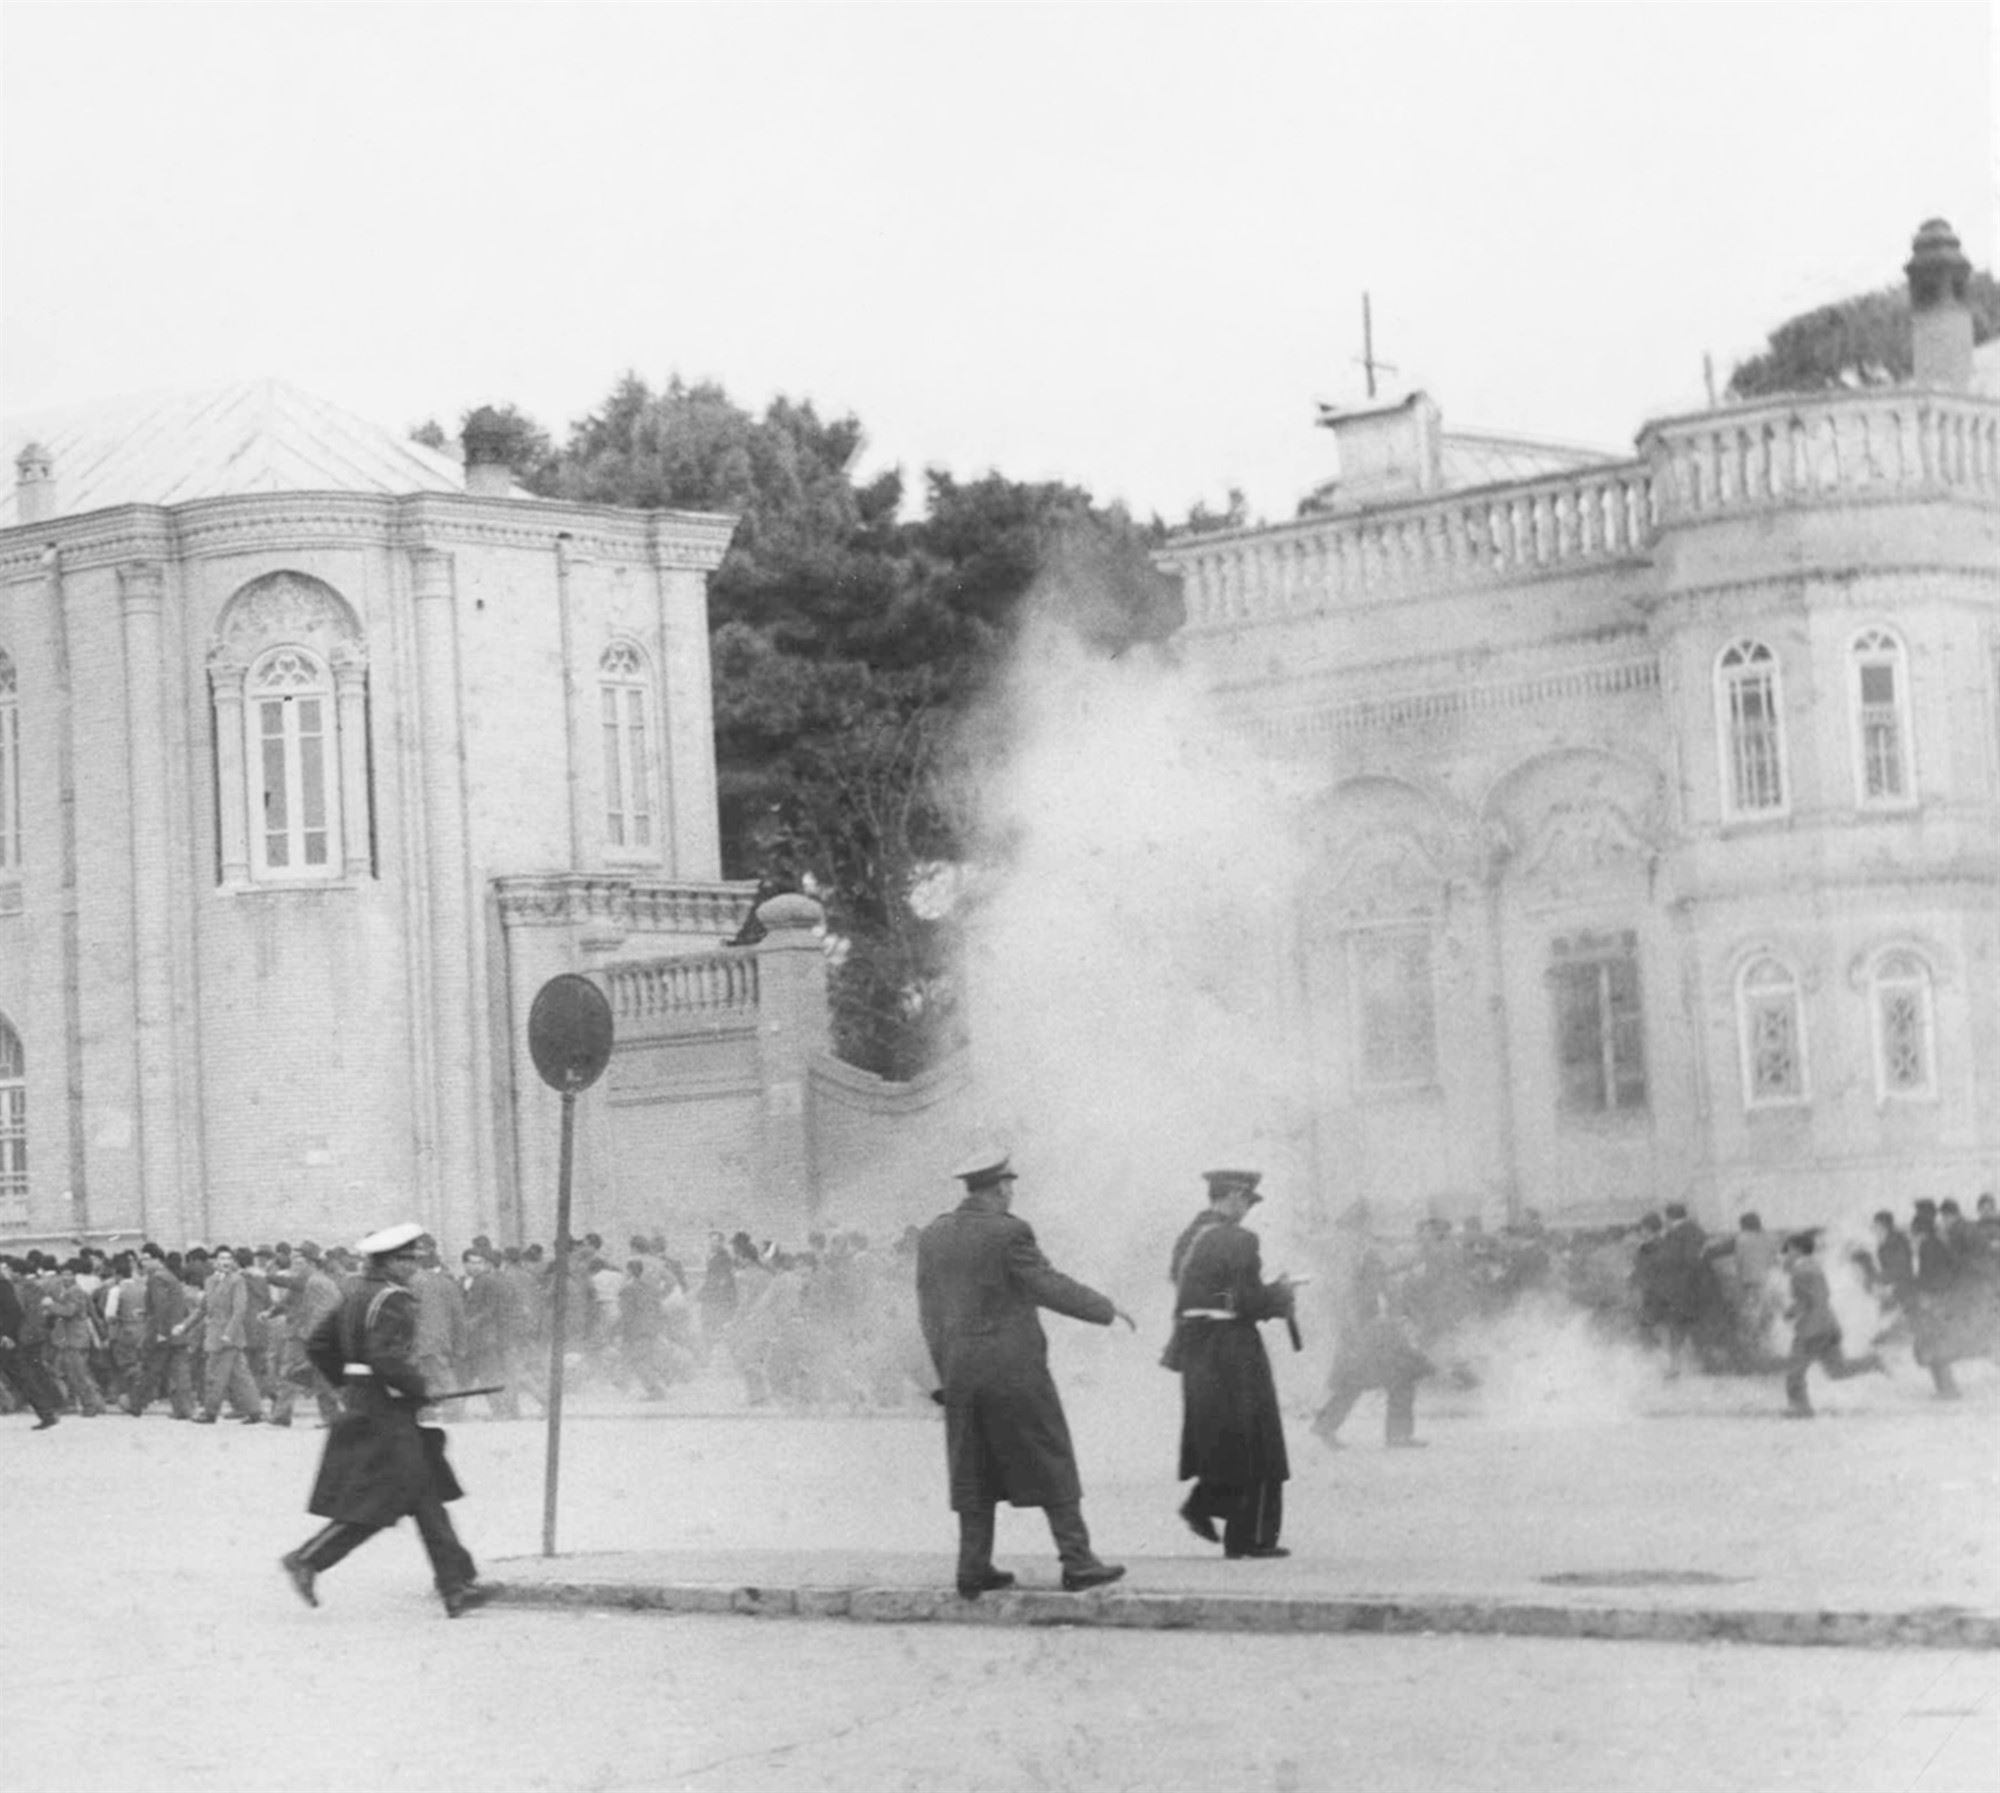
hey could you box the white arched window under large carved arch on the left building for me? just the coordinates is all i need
[244,646,340,878]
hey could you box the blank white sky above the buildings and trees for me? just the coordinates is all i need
[0,0,2000,516]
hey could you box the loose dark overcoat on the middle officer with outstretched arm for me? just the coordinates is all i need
[916,1195,1116,1513]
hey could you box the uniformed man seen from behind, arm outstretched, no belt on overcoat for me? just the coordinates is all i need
[916,1147,1132,1599]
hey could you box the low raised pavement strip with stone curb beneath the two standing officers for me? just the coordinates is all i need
[492,1551,2000,1649]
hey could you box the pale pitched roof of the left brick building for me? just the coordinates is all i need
[0,380,482,528]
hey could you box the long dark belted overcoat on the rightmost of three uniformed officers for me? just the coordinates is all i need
[1174,1219,1292,1489]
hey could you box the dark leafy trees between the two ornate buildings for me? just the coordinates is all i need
[482,374,1182,1077]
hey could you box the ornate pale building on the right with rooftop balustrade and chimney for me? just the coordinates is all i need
[1162,222,2000,1221]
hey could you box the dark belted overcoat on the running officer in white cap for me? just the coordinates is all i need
[306,1277,462,1525]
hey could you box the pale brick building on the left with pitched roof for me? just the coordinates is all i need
[0,382,752,1243]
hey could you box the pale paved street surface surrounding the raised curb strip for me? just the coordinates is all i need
[0,1347,2000,1793]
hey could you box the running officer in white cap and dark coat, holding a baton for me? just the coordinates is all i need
[282,1223,488,1619]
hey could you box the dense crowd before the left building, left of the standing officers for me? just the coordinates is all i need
[0,1229,928,1429]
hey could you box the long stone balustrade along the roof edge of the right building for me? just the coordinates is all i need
[1154,386,2000,630]
